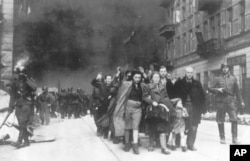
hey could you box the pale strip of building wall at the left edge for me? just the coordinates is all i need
[0,0,32,87]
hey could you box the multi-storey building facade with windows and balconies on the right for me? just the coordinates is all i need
[159,0,250,108]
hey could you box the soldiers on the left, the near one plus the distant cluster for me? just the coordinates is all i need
[6,71,90,148]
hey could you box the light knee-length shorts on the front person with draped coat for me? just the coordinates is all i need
[125,100,142,130]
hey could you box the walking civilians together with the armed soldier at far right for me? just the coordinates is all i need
[91,64,244,154]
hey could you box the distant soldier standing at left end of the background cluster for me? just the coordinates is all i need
[38,86,54,125]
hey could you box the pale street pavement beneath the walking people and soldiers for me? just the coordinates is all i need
[0,115,250,161]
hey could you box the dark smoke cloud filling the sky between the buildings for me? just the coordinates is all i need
[16,0,167,90]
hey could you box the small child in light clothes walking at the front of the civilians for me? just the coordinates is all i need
[169,99,188,152]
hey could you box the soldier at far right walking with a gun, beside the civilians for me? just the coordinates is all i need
[209,64,245,144]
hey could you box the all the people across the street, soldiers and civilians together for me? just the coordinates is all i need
[1,64,245,154]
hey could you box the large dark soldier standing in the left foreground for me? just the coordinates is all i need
[9,72,36,148]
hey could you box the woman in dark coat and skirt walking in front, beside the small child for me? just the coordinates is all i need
[143,73,173,154]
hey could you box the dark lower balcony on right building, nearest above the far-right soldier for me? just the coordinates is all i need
[197,39,225,58]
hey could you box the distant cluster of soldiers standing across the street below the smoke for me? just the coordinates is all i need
[36,86,90,125]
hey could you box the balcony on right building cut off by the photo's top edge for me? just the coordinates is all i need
[198,0,223,13]
